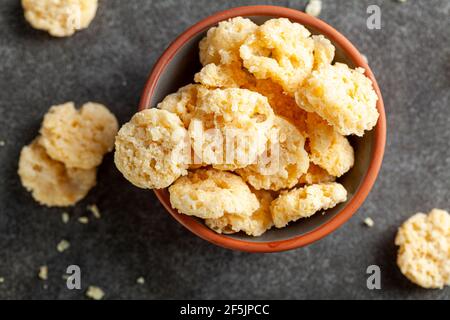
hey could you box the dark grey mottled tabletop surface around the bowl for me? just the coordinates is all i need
[0,0,450,299]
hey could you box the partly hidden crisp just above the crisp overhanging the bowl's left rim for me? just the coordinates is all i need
[156,84,205,129]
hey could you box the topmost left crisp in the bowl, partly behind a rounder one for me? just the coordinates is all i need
[199,17,258,66]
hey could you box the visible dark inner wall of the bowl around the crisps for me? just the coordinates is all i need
[148,16,374,242]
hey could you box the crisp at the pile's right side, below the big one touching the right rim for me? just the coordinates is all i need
[306,113,355,177]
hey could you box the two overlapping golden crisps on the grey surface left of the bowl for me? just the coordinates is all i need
[18,102,118,207]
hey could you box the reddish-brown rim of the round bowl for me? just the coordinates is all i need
[139,5,386,253]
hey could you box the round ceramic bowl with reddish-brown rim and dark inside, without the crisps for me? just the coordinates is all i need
[139,6,386,252]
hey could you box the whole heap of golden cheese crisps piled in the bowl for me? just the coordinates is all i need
[116,17,378,236]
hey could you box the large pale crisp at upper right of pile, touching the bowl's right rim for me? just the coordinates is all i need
[295,63,379,136]
